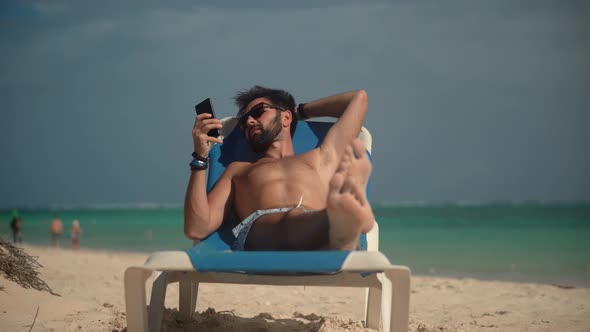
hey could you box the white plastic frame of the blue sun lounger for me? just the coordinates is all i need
[125,119,410,332]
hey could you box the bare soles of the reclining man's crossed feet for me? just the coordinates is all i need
[327,139,375,250]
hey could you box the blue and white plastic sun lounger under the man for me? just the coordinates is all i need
[125,118,410,332]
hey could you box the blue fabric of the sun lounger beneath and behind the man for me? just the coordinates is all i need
[186,121,367,273]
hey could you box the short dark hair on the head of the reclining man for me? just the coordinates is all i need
[234,85,297,137]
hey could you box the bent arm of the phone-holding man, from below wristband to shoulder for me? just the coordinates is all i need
[184,164,234,240]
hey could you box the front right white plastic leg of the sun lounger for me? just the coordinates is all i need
[381,267,410,332]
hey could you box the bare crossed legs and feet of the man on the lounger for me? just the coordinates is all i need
[246,139,375,250]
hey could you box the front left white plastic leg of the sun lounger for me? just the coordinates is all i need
[125,267,152,332]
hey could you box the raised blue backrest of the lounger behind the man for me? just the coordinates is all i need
[202,118,371,249]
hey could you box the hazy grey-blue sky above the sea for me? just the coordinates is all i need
[0,0,590,208]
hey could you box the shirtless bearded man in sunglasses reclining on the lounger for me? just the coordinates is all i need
[184,86,374,250]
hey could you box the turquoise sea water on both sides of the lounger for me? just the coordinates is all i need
[0,203,590,286]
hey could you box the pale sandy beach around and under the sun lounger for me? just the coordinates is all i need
[0,246,590,332]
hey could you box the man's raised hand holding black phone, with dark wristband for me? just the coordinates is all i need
[190,98,223,170]
